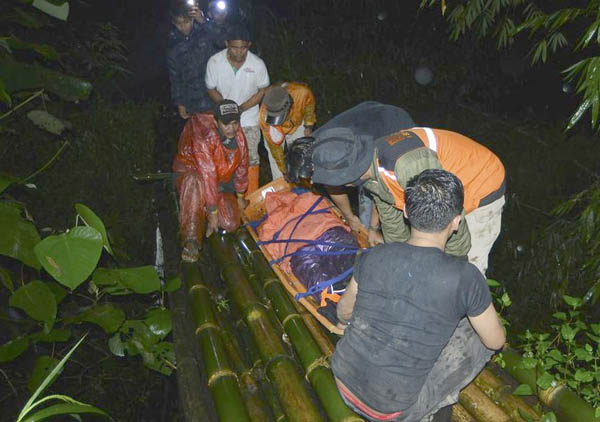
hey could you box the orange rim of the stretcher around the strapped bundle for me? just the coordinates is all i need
[242,178,368,335]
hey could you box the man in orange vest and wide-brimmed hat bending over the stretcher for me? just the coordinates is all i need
[290,101,505,274]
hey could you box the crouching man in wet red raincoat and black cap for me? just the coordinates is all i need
[173,100,248,262]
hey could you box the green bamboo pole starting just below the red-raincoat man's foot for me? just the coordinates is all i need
[182,264,250,422]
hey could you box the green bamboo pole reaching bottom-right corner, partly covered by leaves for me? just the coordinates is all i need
[502,348,600,422]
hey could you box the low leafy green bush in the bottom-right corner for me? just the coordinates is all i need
[513,295,600,416]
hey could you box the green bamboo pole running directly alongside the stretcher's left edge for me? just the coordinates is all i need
[238,231,362,422]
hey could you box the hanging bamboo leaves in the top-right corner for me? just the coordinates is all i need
[421,0,600,129]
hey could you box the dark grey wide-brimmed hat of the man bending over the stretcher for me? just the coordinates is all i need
[312,136,375,186]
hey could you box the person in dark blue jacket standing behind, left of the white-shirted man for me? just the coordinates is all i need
[167,2,218,119]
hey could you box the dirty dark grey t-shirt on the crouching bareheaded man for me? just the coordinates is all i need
[331,243,491,413]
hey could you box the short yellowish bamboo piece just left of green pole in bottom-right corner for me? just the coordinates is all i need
[475,368,540,421]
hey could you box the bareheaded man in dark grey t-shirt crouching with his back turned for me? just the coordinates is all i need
[331,170,505,422]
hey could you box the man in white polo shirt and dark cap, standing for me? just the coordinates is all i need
[206,25,269,193]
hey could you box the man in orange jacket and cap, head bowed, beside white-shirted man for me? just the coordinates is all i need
[258,82,317,180]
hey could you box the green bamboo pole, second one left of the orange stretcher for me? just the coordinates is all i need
[208,235,321,422]
